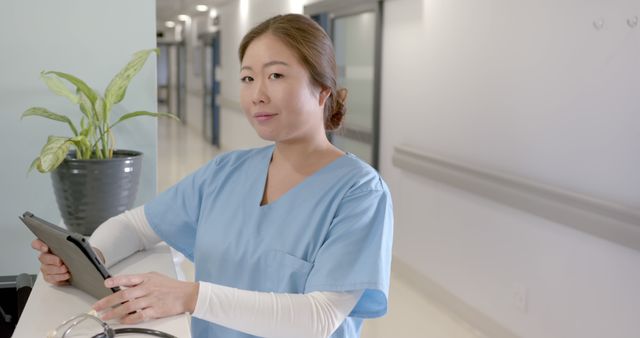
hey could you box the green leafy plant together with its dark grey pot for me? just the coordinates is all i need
[22,49,177,235]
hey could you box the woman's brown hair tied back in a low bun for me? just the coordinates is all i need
[238,14,347,130]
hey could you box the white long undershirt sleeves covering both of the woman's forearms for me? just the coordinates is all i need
[90,207,363,338]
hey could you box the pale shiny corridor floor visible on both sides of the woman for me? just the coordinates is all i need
[158,119,482,338]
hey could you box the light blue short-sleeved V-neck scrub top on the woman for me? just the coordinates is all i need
[144,145,393,338]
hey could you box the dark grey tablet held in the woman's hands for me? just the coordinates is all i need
[20,211,120,299]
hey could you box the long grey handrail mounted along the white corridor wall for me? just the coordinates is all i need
[392,145,640,251]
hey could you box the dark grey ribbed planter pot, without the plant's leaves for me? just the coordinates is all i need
[51,150,142,236]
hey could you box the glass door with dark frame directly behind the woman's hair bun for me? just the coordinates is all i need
[305,0,382,168]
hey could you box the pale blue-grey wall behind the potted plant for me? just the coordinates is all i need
[0,0,157,275]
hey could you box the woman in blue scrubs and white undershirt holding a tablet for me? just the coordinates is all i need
[33,14,393,337]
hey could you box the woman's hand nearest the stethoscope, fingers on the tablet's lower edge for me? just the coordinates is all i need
[93,272,199,324]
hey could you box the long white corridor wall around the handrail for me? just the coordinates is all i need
[381,0,640,338]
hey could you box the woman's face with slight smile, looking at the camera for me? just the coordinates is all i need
[240,33,328,142]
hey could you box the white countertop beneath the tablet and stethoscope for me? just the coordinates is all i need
[13,244,191,338]
